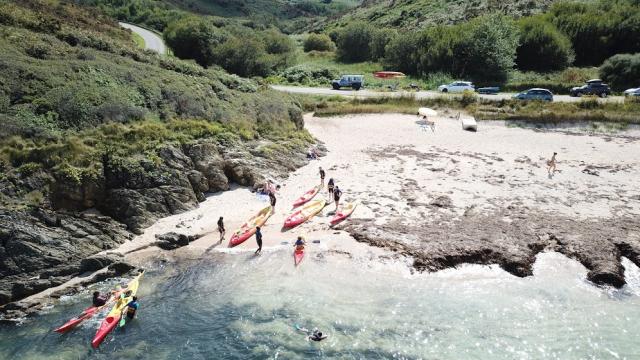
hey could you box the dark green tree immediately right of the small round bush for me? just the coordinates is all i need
[336,22,373,62]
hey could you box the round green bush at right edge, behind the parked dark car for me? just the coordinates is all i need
[600,53,640,91]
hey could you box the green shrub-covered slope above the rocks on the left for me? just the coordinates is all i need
[0,0,310,204]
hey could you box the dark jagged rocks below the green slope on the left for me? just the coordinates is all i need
[0,135,324,318]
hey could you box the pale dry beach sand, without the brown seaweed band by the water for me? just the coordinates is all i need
[118,114,640,264]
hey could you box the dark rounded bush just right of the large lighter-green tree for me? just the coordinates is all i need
[516,17,574,71]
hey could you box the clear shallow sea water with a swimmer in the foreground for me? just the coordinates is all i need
[0,250,640,359]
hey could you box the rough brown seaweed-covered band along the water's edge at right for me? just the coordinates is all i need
[342,207,640,287]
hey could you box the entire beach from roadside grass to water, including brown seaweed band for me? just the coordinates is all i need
[102,114,640,282]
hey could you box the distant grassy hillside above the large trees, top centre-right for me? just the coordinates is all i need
[313,0,558,30]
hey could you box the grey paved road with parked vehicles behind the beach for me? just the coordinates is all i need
[271,85,624,102]
